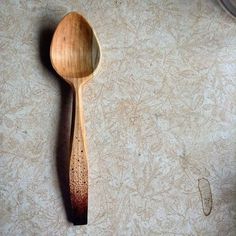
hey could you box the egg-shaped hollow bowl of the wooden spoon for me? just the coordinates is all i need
[50,12,100,81]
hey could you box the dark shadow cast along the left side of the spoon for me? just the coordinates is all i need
[39,24,74,223]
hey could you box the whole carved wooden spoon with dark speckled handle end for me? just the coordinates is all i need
[50,12,100,224]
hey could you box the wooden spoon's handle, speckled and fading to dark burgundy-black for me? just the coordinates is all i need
[69,84,88,225]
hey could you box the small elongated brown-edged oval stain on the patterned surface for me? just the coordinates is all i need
[198,178,212,216]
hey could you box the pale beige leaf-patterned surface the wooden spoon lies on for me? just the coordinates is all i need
[0,0,236,236]
